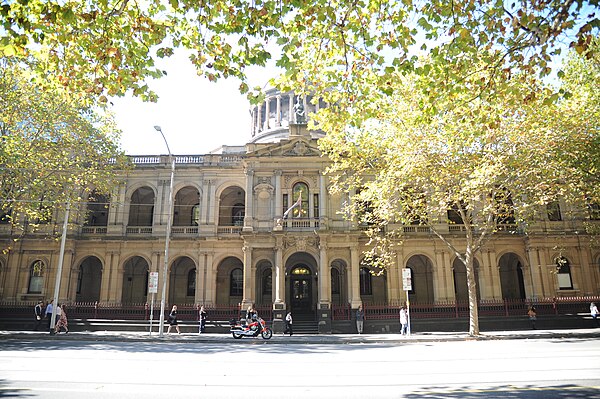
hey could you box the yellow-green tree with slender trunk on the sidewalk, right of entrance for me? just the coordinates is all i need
[318,43,600,334]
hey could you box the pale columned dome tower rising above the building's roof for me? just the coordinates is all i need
[250,89,326,143]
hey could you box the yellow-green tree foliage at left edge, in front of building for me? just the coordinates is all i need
[0,62,126,236]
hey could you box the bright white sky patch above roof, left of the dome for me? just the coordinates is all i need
[111,54,274,155]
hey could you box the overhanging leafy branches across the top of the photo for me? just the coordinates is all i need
[0,0,599,103]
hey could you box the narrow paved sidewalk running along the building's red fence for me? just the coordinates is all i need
[0,328,600,345]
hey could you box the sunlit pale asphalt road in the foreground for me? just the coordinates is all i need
[0,338,600,399]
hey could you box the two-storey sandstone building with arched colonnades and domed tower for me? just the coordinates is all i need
[0,91,600,329]
